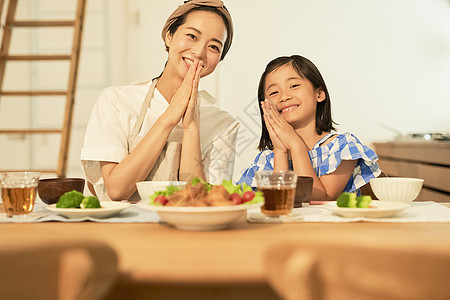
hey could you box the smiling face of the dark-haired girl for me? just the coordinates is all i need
[264,64,325,129]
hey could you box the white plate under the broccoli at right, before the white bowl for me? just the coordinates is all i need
[325,200,409,218]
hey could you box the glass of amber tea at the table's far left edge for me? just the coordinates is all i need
[0,172,40,218]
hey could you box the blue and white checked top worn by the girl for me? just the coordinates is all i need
[236,132,381,194]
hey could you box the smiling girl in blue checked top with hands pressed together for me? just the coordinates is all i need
[238,55,381,200]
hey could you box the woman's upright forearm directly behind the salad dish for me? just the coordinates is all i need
[179,126,206,181]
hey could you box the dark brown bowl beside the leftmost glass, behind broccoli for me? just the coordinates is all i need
[38,178,85,204]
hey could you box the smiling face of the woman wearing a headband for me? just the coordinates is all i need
[166,11,227,78]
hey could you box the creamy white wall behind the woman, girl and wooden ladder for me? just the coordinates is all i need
[0,0,450,180]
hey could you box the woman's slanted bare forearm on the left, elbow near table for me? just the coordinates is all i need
[101,114,174,200]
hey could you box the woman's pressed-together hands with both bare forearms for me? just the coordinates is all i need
[100,60,205,200]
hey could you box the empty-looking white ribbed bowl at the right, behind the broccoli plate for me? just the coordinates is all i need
[369,177,423,203]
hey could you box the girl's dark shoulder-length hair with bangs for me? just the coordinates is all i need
[258,55,336,151]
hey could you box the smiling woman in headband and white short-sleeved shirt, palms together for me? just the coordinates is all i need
[81,0,239,201]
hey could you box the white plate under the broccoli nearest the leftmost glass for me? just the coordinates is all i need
[47,201,131,219]
